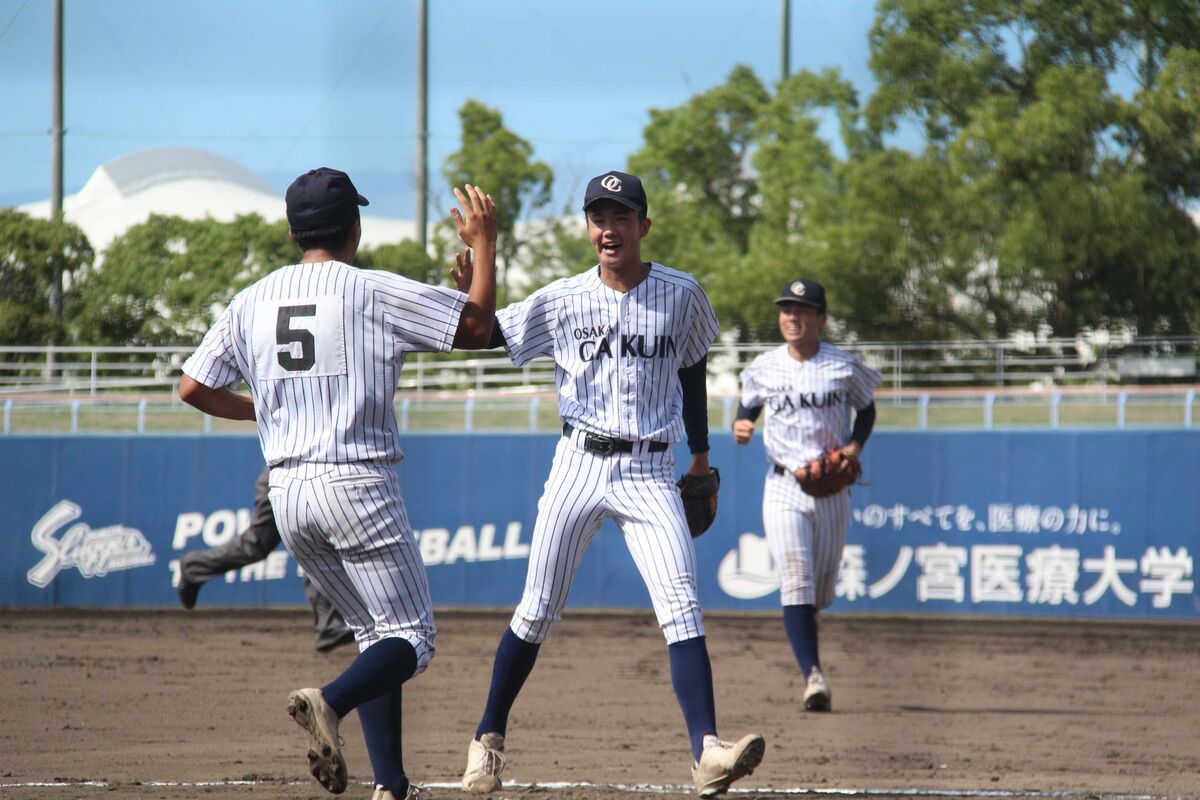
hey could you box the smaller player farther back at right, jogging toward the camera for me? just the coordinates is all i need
[733,279,880,711]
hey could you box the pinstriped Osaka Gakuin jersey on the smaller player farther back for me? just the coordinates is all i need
[742,342,881,471]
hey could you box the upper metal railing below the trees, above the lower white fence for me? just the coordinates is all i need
[0,335,1200,397]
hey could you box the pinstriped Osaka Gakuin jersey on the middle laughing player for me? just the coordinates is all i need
[496,264,719,443]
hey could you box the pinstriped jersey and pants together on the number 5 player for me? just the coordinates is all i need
[184,261,466,672]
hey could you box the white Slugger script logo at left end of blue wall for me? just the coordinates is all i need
[25,500,155,589]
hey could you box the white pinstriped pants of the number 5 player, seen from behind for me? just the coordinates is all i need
[270,463,437,674]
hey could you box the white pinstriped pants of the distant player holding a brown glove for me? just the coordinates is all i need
[762,468,850,608]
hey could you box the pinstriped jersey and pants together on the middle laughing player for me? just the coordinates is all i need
[496,264,718,643]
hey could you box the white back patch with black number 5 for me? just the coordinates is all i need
[252,296,346,380]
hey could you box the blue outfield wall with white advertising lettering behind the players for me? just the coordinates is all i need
[0,429,1200,619]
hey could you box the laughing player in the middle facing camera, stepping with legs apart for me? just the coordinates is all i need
[453,172,764,796]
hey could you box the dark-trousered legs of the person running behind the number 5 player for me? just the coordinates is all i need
[175,467,354,652]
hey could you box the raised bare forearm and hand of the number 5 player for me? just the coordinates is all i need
[450,184,496,350]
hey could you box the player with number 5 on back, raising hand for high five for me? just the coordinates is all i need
[179,168,496,800]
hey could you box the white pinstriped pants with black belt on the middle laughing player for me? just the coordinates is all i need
[510,429,704,644]
